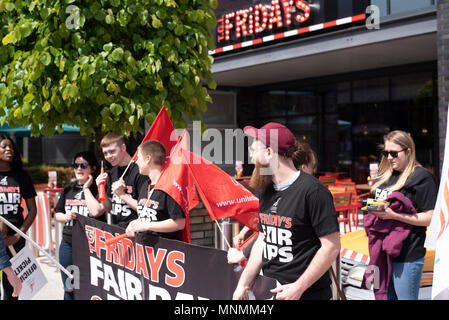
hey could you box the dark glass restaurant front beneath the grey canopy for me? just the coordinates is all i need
[238,63,438,183]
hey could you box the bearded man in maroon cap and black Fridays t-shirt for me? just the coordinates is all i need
[233,122,340,300]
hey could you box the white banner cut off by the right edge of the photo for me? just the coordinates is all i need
[424,106,449,300]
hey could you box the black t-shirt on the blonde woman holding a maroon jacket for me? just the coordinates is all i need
[374,166,438,262]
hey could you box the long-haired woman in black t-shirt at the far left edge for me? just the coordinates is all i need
[0,135,37,300]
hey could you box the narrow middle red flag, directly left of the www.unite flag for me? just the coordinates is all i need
[154,130,198,243]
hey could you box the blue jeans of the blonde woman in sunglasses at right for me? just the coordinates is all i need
[387,258,424,300]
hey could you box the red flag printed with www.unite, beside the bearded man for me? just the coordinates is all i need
[183,150,259,231]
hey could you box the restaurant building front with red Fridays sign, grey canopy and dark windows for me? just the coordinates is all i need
[211,0,440,183]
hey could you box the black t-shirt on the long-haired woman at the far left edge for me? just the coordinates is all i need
[0,170,36,235]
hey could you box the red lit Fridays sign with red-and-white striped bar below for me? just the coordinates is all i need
[209,0,369,54]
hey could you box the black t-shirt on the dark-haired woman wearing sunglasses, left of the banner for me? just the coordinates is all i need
[55,181,106,244]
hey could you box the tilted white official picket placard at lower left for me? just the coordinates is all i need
[10,246,47,300]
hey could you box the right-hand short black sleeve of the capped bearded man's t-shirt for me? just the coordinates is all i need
[308,187,340,237]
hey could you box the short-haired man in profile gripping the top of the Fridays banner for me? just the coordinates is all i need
[126,140,186,240]
